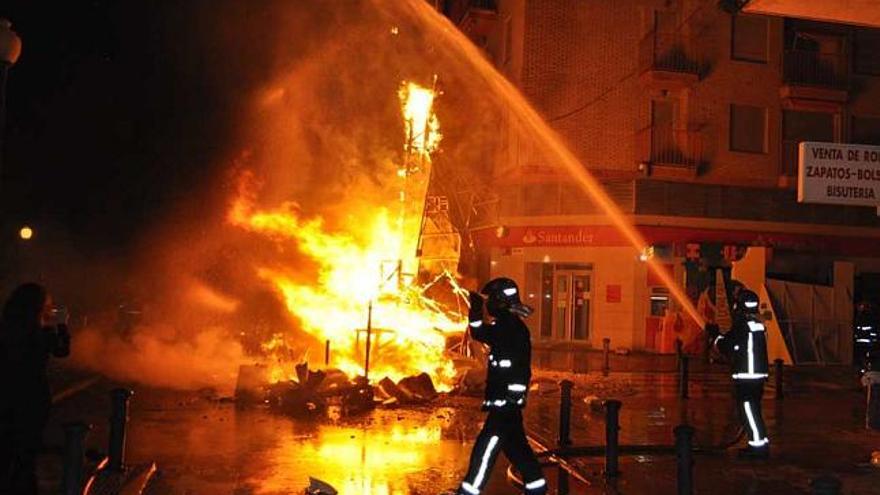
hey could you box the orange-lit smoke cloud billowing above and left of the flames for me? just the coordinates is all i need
[67,0,509,390]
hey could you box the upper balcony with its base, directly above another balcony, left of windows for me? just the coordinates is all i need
[639,31,706,89]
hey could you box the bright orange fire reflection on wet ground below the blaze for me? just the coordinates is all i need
[121,391,488,495]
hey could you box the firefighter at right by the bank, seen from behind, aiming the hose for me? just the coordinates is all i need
[715,288,770,459]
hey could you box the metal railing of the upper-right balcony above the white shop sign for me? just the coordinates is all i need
[782,50,849,89]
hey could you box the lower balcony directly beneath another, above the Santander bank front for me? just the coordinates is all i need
[636,126,703,178]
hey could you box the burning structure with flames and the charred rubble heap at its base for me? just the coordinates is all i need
[228,77,474,404]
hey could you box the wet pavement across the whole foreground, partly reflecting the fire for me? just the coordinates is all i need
[37,368,880,495]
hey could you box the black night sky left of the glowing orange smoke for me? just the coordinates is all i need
[0,0,284,260]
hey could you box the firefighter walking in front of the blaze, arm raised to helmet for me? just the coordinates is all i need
[458,278,547,495]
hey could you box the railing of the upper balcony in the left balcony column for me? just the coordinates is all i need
[639,31,704,76]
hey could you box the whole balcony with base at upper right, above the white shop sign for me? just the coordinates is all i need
[780,50,849,108]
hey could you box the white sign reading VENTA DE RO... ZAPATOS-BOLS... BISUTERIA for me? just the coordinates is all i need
[798,142,880,207]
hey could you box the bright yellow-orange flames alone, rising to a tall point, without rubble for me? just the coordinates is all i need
[228,83,465,390]
